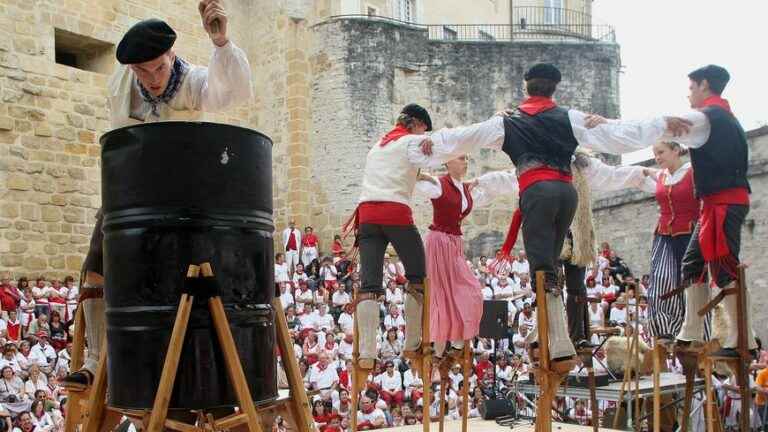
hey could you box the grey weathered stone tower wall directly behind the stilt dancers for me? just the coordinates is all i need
[308,19,619,256]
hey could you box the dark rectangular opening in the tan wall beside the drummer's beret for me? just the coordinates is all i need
[54,28,115,74]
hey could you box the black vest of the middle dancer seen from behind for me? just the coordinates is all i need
[501,107,579,172]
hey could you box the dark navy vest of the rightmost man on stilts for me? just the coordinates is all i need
[691,106,750,198]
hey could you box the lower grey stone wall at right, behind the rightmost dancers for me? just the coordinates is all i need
[594,127,768,340]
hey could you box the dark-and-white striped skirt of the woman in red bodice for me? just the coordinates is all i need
[648,234,710,339]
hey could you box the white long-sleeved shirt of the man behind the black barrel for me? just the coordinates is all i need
[108,41,252,128]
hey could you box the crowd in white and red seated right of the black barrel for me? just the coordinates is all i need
[275,235,768,432]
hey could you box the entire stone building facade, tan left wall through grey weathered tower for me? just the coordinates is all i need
[0,0,619,277]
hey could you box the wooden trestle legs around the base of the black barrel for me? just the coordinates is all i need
[65,263,314,432]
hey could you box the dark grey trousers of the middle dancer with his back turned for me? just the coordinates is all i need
[520,181,579,290]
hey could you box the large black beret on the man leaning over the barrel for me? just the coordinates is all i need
[117,18,176,64]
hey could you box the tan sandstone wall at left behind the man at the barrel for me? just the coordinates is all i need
[0,0,260,277]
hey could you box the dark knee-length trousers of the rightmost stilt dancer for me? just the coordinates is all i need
[682,205,749,288]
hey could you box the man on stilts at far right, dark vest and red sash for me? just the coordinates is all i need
[586,65,757,357]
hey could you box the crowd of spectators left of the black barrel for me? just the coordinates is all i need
[0,276,78,432]
